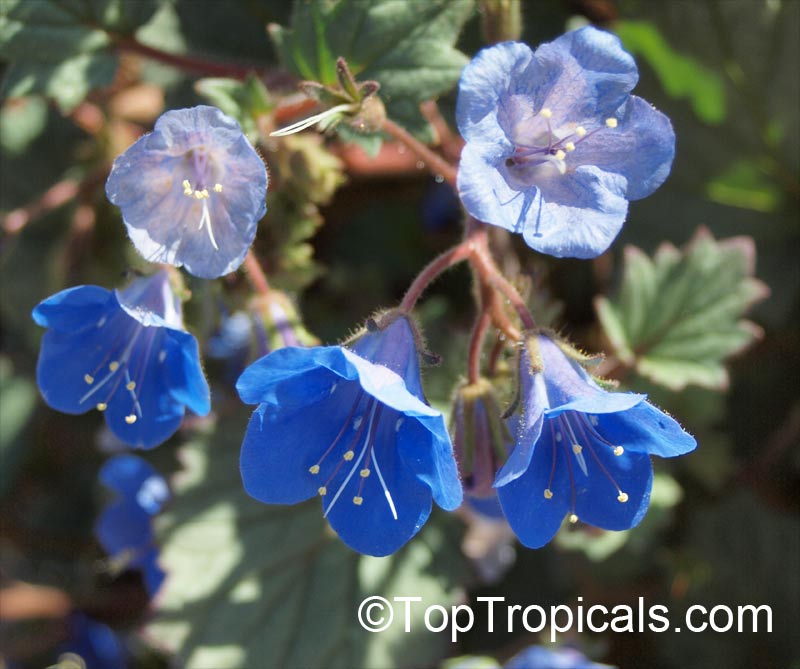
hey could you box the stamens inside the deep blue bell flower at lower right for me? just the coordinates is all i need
[543,411,628,524]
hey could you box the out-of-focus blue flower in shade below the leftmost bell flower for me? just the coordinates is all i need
[95,455,170,596]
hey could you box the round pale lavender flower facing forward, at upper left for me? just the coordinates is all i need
[106,105,267,279]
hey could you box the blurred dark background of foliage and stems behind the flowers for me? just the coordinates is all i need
[0,0,800,669]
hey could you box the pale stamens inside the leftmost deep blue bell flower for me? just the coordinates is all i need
[79,312,166,425]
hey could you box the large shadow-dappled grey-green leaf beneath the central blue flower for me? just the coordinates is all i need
[147,412,465,669]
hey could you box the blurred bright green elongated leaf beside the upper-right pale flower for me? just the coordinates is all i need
[614,21,727,125]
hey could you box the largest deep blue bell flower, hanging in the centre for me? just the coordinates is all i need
[237,317,462,556]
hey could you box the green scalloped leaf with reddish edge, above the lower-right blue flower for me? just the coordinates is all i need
[595,228,769,390]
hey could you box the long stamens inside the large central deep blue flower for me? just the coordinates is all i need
[308,384,402,520]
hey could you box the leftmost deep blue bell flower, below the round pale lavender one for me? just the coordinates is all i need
[33,271,210,448]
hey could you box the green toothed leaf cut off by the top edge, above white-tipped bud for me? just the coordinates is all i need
[270,0,473,137]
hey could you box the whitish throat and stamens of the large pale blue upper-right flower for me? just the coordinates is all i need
[506,107,618,177]
